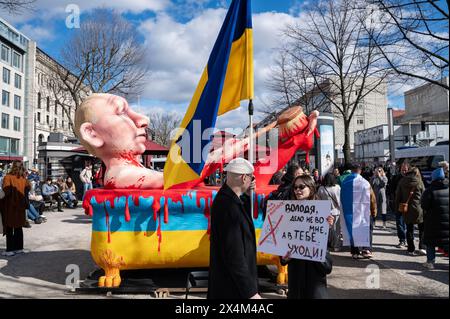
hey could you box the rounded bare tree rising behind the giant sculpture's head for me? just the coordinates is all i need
[48,9,149,135]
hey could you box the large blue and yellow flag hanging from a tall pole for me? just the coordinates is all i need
[164,0,254,189]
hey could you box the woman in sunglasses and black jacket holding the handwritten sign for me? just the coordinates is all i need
[281,175,334,299]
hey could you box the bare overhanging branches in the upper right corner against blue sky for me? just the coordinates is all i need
[366,0,449,90]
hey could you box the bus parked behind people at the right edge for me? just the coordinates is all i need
[395,141,449,186]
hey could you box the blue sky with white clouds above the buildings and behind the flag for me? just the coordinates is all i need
[2,0,414,128]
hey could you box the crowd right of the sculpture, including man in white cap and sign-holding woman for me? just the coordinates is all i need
[208,159,449,299]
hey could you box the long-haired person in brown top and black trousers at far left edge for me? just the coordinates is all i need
[0,161,31,257]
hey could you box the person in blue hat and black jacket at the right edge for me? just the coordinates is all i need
[421,168,449,269]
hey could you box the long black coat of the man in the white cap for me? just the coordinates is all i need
[208,184,258,299]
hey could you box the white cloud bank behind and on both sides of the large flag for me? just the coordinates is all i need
[139,8,298,127]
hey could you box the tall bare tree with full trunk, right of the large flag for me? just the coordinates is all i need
[285,0,389,163]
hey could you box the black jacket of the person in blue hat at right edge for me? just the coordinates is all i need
[421,181,449,246]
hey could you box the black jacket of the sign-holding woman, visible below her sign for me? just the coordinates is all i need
[288,252,333,299]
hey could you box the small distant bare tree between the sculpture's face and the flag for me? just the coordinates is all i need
[149,112,182,147]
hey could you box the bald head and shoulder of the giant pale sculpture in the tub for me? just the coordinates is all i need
[75,94,163,189]
